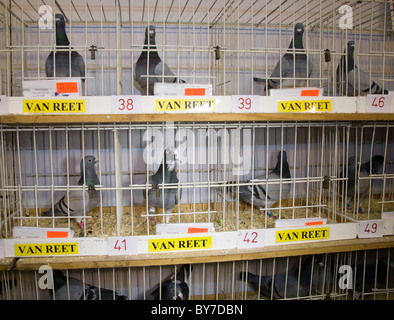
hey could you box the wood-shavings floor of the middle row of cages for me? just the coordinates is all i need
[14,198,394,237]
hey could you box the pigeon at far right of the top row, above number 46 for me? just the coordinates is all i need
[336,41,388,97]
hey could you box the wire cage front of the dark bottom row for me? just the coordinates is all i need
[0,248,394,300]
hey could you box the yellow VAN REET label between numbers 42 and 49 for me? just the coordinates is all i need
[276,227,330,242]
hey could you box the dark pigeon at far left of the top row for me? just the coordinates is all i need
[45,14,85,82]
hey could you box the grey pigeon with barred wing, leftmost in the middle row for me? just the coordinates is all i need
[42,156,100,229]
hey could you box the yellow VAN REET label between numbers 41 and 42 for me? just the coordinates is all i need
[149,236,212,252]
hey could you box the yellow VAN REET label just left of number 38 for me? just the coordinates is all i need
[23,99,86,113]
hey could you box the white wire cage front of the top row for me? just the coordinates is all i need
[0,0,394,96]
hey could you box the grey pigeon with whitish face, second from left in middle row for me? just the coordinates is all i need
[143,147,182,223]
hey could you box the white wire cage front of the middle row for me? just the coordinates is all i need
[0,121,393,238]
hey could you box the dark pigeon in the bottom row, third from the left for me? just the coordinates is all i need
[239,256,322,299]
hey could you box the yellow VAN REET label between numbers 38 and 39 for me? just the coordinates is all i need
[155,99,215,112]
